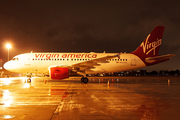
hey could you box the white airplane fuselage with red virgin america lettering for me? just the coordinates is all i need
[4,53,146,74]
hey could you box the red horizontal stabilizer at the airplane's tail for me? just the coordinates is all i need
[145,54,175,63]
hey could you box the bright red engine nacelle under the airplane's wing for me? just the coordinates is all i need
[49,67,69,80]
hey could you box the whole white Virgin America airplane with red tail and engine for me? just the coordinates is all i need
[4,26,175,83]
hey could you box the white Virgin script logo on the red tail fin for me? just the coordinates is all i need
[140,34,162,55]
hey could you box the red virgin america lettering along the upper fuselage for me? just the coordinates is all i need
[35,53,97,59]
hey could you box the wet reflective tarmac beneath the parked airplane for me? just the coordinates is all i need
[0,77,180,120]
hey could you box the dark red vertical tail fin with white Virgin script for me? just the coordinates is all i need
[132,26,165,59]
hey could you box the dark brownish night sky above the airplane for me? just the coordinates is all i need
[0,0,180,70]
